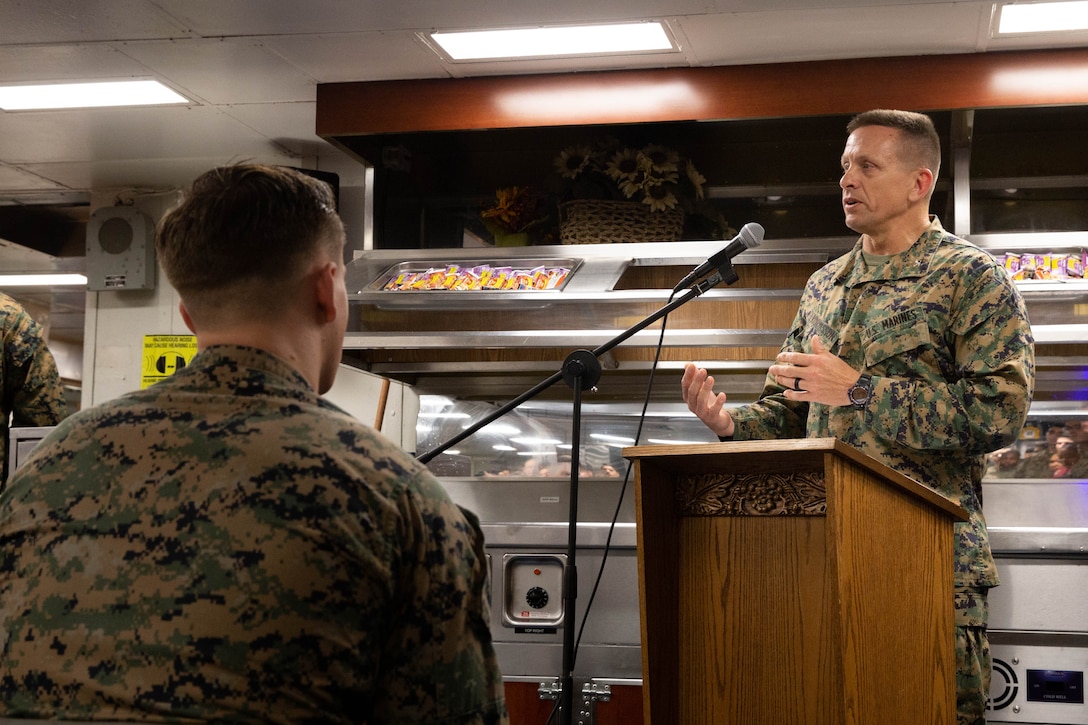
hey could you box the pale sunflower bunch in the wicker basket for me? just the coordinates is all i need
[554,137,729,238]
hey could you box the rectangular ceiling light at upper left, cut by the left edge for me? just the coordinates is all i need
[0,81,189,111]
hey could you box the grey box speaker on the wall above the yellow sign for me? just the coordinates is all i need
[87,207,156,291]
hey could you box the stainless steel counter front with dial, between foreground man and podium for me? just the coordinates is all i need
[442,477,642,725]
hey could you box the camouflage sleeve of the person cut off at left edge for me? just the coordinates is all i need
[3,312,65,426]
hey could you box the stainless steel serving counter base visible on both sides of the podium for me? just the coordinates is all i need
[443,477,1088,725]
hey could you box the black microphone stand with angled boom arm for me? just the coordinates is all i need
[416,259,740,725]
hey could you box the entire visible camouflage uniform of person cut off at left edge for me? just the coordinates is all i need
[0,292,67,489]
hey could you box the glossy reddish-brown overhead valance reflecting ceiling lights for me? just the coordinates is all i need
[317,49,1088,142]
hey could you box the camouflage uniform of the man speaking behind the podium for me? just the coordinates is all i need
[730,218,1035,725]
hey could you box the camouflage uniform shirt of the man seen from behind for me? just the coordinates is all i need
[0,345,507,725]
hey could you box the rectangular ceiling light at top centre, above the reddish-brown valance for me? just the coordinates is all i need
[431,22,676,61]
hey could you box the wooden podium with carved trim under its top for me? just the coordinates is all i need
[623,439,967,725]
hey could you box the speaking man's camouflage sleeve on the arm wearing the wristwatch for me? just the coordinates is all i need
[866,257,1035,455]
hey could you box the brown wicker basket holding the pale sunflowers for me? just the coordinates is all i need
[559,199,683,244]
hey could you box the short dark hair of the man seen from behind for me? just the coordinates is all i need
[156,164,344,299]
